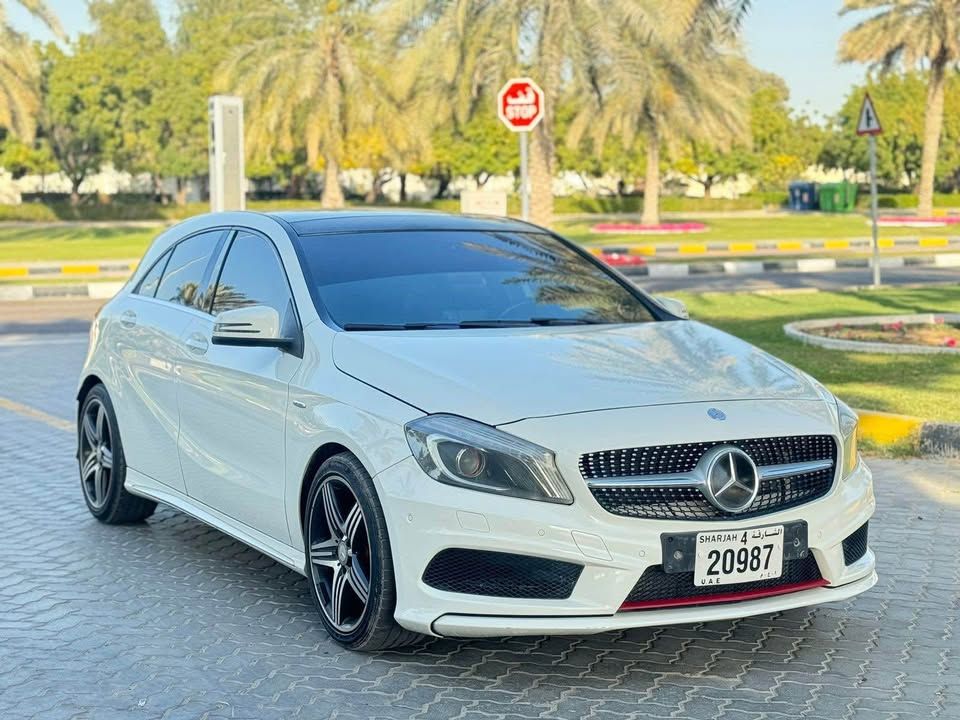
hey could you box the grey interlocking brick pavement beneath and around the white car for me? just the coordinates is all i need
[0,330,960,720]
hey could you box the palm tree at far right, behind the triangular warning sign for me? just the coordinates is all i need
[840,0,960,217]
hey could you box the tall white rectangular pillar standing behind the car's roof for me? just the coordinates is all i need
[208,95,246,212]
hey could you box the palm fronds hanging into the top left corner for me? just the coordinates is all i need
[0,0,64,142]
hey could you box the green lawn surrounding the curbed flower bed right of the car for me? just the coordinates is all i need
[673,287,960,422]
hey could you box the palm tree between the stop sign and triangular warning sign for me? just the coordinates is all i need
[567,3,753,225]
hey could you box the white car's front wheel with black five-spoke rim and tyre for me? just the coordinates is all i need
[303,453,423,652]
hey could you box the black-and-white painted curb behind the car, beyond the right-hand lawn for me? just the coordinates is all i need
[616,253,960,277]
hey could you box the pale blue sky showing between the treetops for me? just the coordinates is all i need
[10,0,864,119]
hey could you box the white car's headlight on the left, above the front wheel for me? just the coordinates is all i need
[404,415,573,505]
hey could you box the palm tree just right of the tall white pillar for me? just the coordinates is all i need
[218,0,389,208]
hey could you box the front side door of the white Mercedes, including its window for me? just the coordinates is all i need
[179,230,300,543]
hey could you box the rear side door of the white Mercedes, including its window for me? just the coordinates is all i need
[111,230,224,492]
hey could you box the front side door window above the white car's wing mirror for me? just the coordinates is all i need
[213,231,292,319]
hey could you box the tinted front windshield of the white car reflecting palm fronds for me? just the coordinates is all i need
[300,230,654,330]
